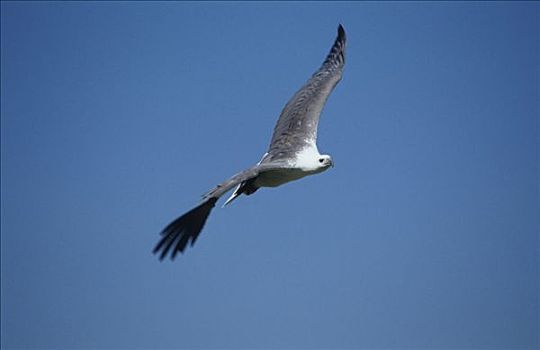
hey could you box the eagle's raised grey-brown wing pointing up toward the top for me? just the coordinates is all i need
[267,24,346,161]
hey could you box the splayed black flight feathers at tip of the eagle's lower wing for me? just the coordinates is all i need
[153,197,218,260]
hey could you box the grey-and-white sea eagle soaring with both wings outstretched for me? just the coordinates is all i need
[154,24,346,260]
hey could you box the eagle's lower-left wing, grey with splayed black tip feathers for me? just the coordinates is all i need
[153,163,282,260]
